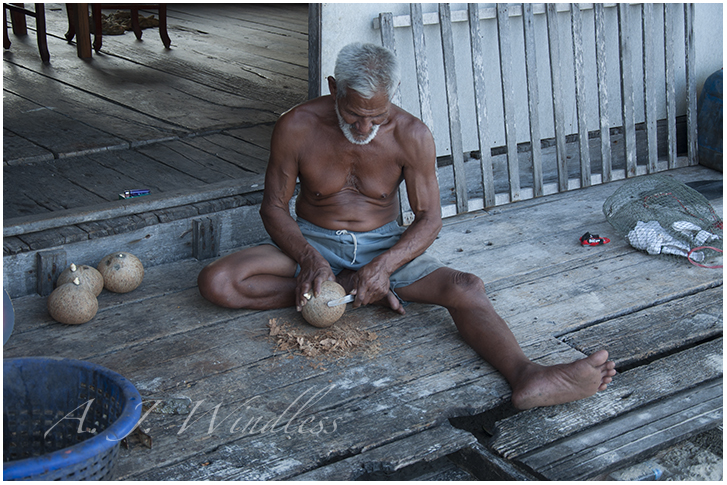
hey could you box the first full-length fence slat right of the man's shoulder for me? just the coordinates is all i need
[439,3,468,214]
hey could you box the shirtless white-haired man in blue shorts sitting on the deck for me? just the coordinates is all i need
[198,44,616,409]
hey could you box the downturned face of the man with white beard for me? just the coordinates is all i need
[335,90,390,145]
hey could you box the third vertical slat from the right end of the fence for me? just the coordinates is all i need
[641,3,658,173]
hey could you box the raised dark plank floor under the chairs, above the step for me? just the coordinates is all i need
[3,4,308,221]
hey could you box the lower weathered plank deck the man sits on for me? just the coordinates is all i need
[4,167,722,479]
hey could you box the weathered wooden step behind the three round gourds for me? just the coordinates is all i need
[3,175,267,298]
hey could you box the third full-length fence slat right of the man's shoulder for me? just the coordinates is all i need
[496,3,520,202]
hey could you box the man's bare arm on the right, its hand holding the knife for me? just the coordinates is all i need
[354,120,442,306]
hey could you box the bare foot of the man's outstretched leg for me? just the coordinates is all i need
[511,350,616,409]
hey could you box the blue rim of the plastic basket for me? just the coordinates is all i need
[3,357,142,480]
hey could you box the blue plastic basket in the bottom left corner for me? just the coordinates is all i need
[3,357,141,480]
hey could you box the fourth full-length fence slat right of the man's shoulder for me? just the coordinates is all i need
[522,3,543,197]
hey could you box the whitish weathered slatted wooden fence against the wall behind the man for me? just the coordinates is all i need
[373,3,697,219]
